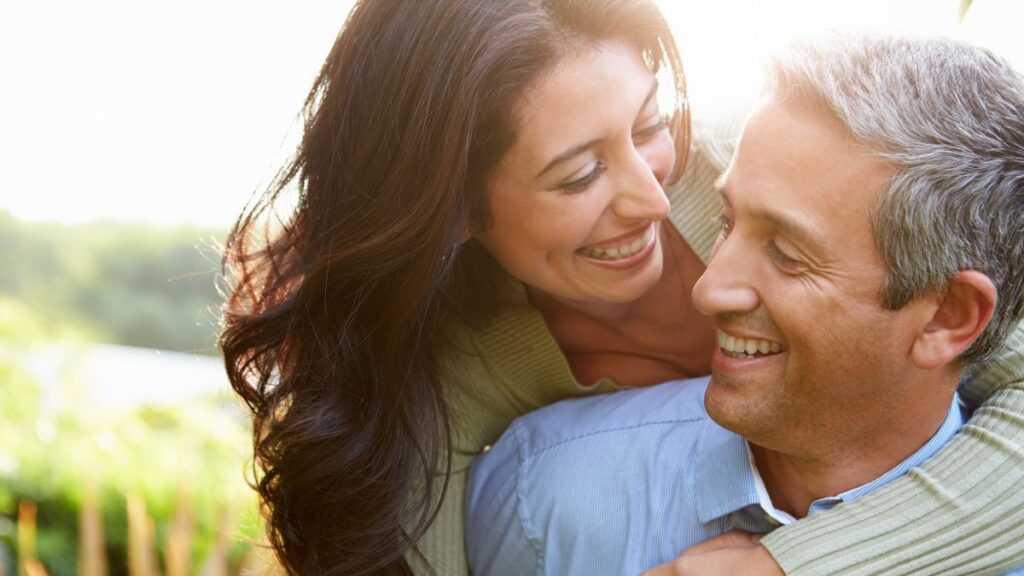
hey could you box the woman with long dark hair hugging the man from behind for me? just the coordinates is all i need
[221,0,1024,574]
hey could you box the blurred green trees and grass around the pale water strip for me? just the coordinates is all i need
[0,212,262,576]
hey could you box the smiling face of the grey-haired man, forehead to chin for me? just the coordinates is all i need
[693,99,924,456]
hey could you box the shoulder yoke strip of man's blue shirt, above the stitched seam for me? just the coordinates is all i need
[504,377,708,457]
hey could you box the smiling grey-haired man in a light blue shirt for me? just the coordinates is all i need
[467,37,1024,576]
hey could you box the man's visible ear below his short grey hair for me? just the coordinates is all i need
[910,270,996,370]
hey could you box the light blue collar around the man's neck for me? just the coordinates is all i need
[696,394,964,524]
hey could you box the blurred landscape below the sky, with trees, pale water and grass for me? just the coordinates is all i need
[0,213,269,576]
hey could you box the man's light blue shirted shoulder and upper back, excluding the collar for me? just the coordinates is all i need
[466,378,710,574]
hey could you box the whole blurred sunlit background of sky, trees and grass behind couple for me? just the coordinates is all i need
[0,0,1024,576]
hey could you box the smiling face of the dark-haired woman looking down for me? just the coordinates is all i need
[475,41,676,307]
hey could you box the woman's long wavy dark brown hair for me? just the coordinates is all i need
[220,0,689,575]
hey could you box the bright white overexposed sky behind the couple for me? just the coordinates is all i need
[0,0,1024,227]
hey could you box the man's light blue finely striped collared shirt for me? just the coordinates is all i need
[466,378,1011,576]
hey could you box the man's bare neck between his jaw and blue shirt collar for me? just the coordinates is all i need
[750,389,950,519]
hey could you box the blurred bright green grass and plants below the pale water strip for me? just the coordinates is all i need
[0,294,261,576]
